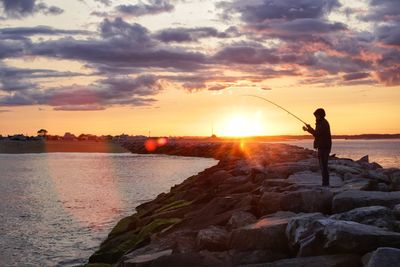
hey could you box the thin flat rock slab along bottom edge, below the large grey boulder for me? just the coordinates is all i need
[240,254,360,267]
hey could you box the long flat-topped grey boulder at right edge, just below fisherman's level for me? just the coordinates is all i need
[332,190,400,213]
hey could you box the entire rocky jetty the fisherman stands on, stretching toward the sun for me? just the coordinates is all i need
[86,142,400,267]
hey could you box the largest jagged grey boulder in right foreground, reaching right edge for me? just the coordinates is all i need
[287,218,400,256]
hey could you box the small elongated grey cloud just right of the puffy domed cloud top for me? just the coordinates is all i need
[154,27,239,43]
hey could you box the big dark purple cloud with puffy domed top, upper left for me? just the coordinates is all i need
[31,18,206,71]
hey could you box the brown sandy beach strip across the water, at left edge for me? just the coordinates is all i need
[0,140,129,154]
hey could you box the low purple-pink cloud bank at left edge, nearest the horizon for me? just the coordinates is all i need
[0,75,163,110]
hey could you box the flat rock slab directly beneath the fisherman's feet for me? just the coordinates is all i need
[287,171,343,187]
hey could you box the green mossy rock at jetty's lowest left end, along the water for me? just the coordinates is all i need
[89,218,181,263]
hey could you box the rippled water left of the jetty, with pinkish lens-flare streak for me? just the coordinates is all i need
[0,153,217,267]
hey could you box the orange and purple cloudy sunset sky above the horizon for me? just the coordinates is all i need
[0,0,400,136]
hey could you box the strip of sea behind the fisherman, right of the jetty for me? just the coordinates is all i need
[276,139,400,168]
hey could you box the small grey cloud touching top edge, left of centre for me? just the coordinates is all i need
[116,0,174,17]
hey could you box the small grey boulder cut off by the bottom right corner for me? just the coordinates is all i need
[366,248,400,267]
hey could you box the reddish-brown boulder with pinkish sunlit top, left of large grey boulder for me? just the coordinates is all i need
[229,212,295,252]
